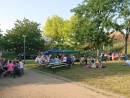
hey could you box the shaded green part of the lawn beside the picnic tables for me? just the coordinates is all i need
[30,62,130,81]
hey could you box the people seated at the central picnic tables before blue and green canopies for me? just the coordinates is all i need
[35,54,75,66]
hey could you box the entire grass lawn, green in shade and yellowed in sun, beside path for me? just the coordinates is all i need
[26,61,130,97]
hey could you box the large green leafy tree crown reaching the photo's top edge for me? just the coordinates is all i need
[71,0,128,55]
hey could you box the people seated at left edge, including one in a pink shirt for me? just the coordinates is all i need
[0,58,24,78]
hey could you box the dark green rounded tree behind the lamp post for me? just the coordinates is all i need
[3,18,44,54]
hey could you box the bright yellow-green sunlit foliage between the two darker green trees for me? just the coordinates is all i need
[43,15,70,48]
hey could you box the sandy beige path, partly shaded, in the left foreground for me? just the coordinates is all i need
[0,69,122,98]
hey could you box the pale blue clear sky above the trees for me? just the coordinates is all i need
[0,0,83,34]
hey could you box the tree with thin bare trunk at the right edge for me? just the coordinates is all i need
[113,0,130,54]
